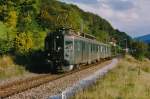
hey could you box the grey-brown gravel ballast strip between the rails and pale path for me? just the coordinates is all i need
[5,61,117,99]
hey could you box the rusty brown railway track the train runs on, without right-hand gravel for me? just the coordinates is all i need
[0,60,110,99]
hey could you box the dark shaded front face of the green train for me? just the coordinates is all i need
[45,29,73,72]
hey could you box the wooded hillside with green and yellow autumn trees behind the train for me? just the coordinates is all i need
[0,0,130,53]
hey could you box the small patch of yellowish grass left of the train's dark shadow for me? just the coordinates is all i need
[0,56,26,79]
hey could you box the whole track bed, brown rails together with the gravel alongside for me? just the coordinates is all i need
[0,60,111,99]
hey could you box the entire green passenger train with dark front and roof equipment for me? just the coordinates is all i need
[45,28,111,71]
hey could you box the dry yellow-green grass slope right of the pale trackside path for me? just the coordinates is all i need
[73,56,150,99]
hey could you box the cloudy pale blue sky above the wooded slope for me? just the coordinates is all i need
[60,0,150,37]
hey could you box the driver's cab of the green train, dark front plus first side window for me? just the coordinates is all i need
[45,28,73,71]
